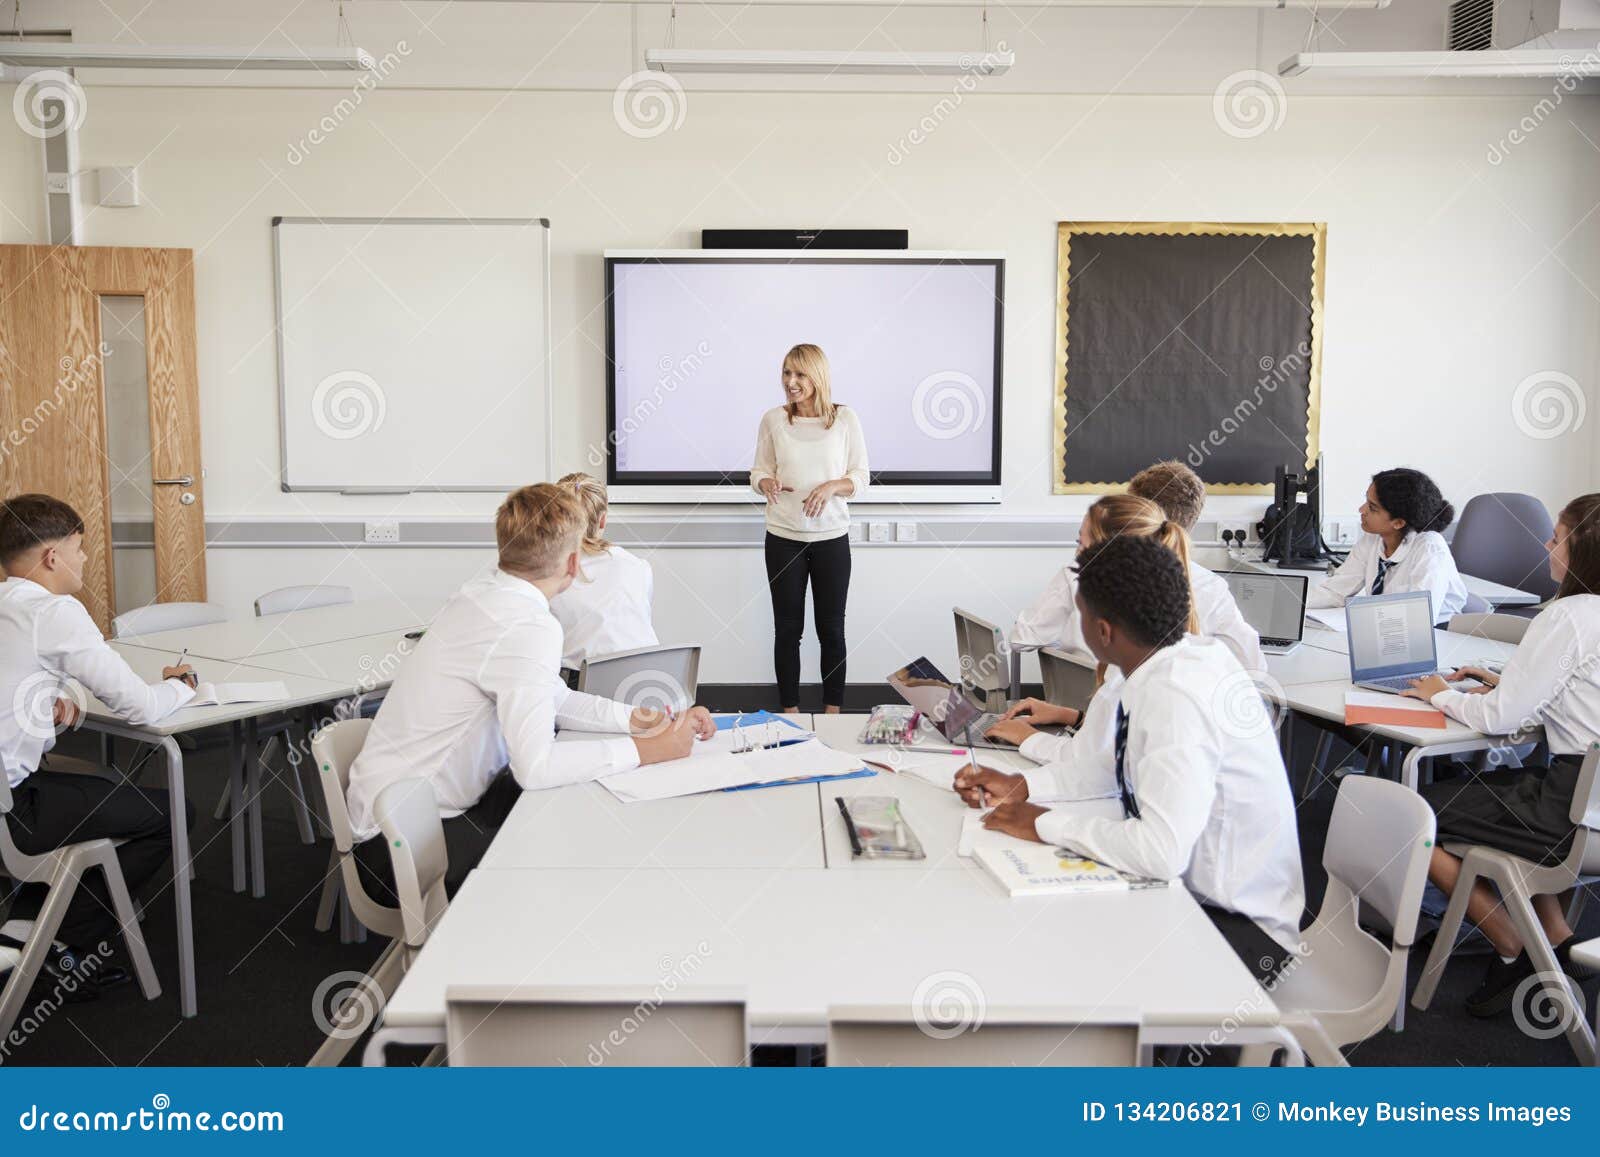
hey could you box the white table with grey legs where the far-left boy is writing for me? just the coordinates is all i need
[83,643,350,1016]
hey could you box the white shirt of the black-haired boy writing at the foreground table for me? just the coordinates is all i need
[1022,637,1306,947]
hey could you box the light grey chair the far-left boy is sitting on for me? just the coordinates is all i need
[0,775,162,1040]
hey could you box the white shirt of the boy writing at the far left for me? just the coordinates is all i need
[0,578,195,787]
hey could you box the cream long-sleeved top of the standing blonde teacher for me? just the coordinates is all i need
[750,406,869,542]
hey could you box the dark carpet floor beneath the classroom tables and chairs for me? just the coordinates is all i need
[0,723,1600,1066]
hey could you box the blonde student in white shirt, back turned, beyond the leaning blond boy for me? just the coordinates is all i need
[550,474,659,671]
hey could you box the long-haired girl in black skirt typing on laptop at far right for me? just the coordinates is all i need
[1406,494,1600,1016]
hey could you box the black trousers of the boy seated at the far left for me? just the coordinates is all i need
[6,771,195,949]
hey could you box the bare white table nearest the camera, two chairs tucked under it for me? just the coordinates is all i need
[366,867,1296,1064]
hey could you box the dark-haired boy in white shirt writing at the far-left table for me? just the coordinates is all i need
[0,494,195,987]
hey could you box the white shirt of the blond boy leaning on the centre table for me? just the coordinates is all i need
[347,570,638,840]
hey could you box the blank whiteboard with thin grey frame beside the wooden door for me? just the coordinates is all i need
[272,218,554,493]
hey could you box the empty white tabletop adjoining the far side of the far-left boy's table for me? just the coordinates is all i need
[117,599,438,661]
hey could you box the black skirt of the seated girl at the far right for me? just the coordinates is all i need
[1422,755,1582,866]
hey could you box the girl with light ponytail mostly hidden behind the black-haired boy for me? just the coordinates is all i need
[986,494,1203,752]
